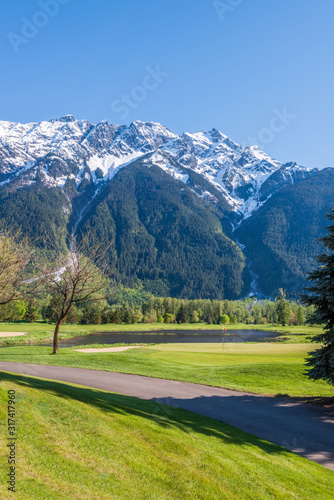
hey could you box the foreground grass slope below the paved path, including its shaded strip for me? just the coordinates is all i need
[0,374,334,500]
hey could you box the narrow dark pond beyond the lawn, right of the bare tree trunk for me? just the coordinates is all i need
[55,330,278,347]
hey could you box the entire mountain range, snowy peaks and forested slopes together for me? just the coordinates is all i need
[0,116,334,299]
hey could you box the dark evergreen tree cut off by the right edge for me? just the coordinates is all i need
[302,209,334,385]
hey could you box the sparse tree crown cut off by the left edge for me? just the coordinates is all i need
[0,228,38,305]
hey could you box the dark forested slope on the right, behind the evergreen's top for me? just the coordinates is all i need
[235,168,334,298]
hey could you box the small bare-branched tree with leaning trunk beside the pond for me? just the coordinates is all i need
[42,235,109,354]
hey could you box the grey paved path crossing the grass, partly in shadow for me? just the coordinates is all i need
[0,361,334,470]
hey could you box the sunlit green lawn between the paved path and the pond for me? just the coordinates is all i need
[0,343,334,397]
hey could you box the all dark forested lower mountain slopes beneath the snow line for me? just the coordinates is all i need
[0,160,334,300]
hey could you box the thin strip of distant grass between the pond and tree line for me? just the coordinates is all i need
[0,322,322,346]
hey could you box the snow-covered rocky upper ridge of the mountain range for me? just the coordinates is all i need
[0,115,314,220]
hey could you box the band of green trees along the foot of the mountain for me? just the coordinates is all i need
[0,286,314,325]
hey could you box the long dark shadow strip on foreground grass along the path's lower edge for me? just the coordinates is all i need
[0,372,294,454]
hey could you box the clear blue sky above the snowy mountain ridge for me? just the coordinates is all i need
[0,0,334,167]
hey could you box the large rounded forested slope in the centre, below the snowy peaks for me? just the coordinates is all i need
[80,165,247,299]
